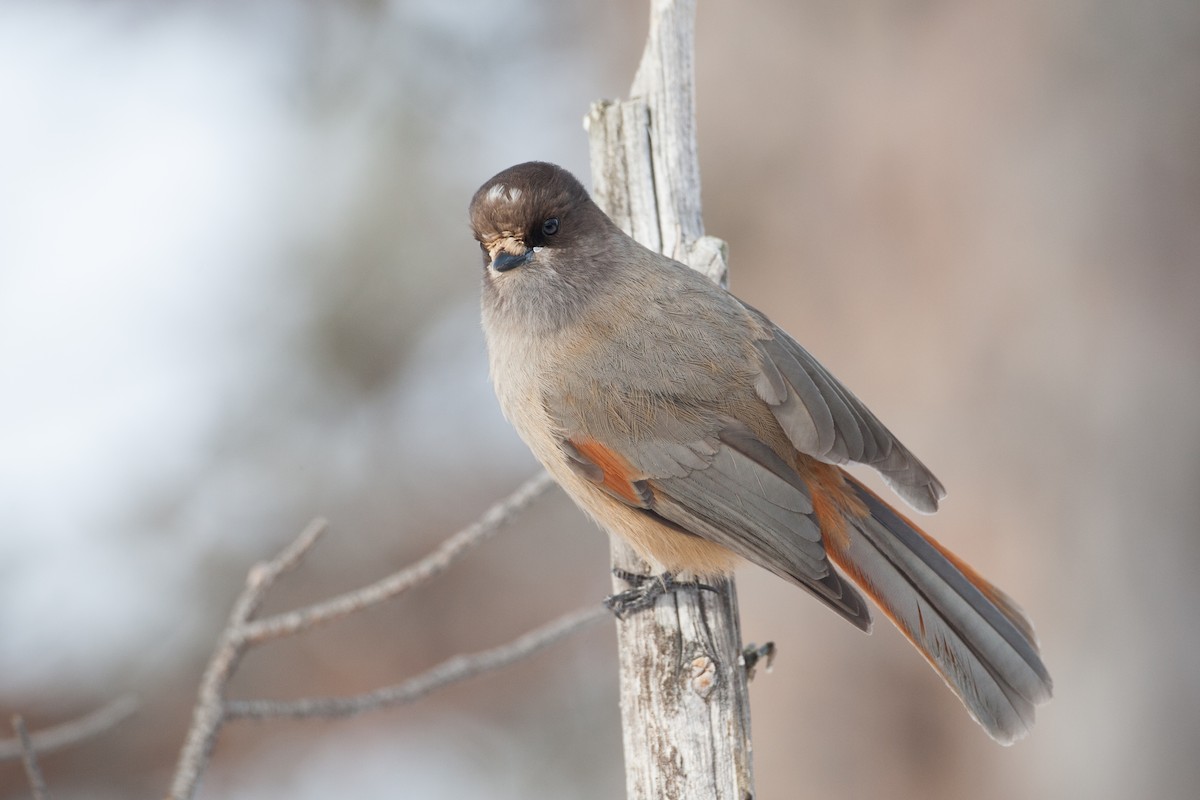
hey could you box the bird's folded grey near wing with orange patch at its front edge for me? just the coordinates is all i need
[564,420,871,631]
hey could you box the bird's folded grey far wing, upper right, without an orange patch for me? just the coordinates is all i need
[743,303,946,513]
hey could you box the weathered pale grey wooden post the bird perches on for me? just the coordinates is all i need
[586,0,754,800]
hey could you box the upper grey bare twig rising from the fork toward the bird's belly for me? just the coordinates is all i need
[241,473,553,643]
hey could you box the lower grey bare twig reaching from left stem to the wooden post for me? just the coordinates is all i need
[226,603,611,720]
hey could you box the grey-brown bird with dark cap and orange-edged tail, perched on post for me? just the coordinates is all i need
[469,162,1052,745]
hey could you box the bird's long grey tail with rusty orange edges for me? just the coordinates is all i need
[826,473,1052,745]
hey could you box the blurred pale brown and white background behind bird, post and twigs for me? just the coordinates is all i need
[0,0,1200,799]
